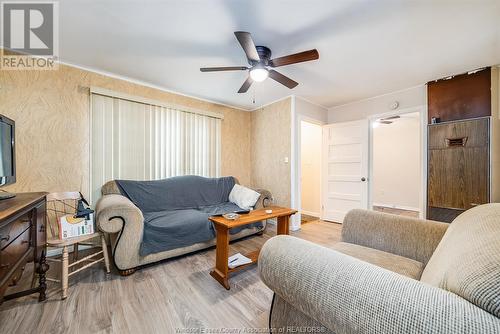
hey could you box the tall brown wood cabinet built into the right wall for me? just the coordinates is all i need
[427,67,500,222]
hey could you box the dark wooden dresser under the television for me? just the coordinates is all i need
[0,192,49,303]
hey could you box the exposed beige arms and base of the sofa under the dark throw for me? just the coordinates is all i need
[95,181,272,275]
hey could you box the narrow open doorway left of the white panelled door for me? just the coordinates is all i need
[300,121,322,224]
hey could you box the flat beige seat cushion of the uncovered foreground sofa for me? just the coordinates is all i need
[333,242,424,280]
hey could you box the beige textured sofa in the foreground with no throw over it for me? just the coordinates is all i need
[259,204,500,334]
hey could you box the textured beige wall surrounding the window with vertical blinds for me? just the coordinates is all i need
[0,65,251,194]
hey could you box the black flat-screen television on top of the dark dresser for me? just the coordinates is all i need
[0,115,16,199]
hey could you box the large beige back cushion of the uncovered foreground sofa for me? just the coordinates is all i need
[421,203,500,317]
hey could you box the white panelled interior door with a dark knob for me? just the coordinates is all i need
[322,119,369,223]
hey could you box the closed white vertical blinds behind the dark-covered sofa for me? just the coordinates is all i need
[90,93,221,203]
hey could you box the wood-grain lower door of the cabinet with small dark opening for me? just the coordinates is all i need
[428,118,489,209]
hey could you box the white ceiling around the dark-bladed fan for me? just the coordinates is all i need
[59,0,500,109]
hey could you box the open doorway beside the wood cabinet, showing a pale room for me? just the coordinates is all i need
[370,112,424,217]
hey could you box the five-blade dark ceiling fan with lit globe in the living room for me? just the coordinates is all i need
[200,31,319,93]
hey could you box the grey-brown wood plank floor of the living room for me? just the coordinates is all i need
[0,221,342,334]
